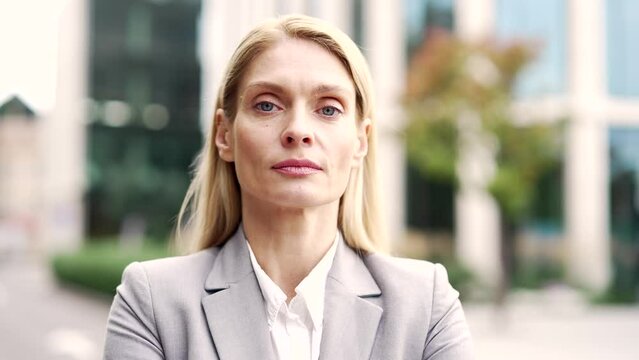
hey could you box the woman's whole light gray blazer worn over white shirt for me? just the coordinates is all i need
[104,232,472,360]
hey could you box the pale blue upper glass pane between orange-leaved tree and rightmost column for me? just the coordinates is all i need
[495,0,567,97]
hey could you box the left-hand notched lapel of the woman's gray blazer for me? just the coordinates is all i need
[202,229,274,360]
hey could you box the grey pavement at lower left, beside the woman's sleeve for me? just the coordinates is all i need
[0,257,111,360]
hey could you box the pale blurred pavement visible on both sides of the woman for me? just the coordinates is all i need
[0,258,639,360]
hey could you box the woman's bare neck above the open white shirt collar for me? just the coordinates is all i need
[242,198,339,300]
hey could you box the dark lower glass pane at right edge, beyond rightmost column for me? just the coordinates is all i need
[609,127,639,300]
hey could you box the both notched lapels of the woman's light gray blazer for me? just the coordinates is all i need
[202,226,382,360]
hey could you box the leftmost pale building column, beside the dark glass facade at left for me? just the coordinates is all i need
[40,0,89,252]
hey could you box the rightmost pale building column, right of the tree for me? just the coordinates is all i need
[564,0,611,291]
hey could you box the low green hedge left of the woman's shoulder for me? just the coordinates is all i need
[51,240,170,295]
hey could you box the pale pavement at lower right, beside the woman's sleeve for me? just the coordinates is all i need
[464,290,639,360]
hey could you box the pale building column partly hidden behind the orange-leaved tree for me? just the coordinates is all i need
[455,0,502,289]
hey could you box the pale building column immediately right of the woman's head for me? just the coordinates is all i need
[363,0,406,248]
